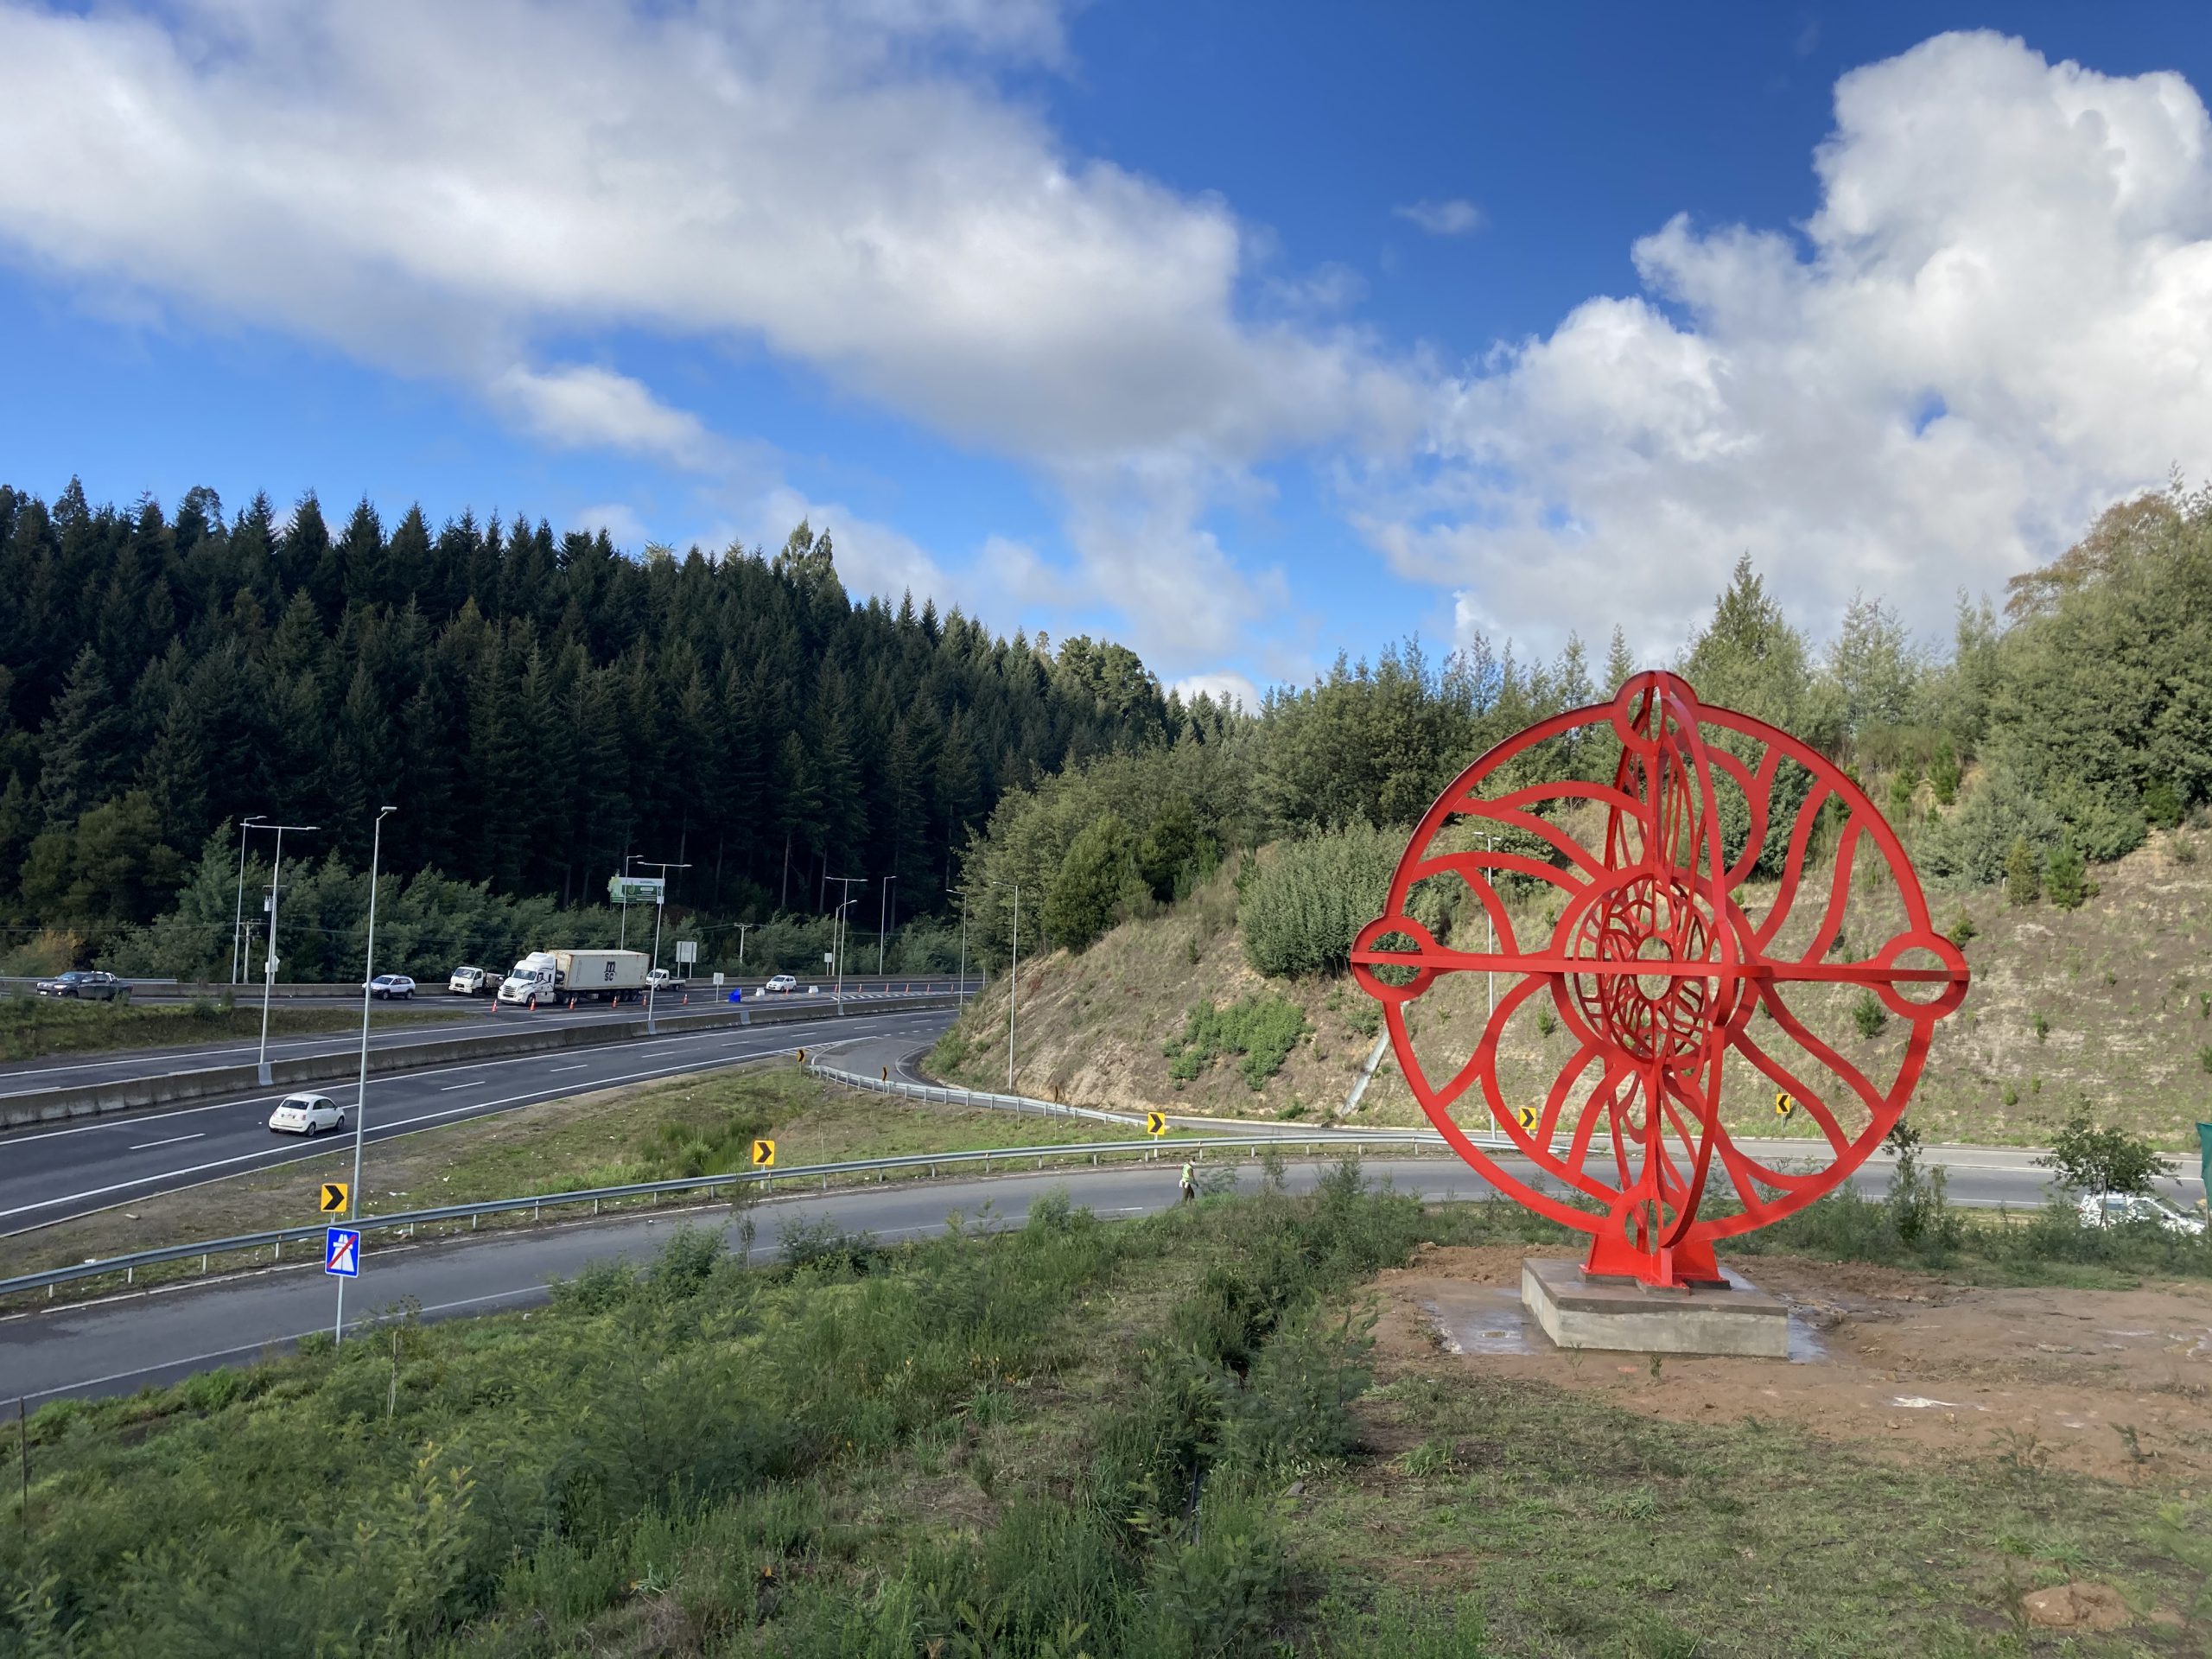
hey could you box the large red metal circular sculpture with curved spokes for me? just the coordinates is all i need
[1351,672,1967,1285]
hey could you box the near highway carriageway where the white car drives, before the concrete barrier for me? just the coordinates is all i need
[0,1004,951,1239]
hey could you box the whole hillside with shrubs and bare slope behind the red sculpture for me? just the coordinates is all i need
[938,491,2212,1150]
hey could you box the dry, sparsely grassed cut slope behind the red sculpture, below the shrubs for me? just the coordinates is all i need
[933,836,2212,1153]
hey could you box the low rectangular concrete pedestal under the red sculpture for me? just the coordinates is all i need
[1522,1256,1789,1360]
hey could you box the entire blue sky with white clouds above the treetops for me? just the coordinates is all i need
[0,0,2212,699]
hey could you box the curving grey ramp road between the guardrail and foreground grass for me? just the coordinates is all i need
[0,1150,2194,1407]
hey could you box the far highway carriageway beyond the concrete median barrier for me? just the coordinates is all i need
[0,976,956,1097]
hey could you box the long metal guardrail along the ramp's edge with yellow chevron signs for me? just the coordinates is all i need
[0,1141,1449,1296]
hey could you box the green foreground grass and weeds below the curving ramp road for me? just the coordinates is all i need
[0,1166,2212,1659]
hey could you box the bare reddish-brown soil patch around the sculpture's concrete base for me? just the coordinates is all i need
[1376,1245,2212,1493]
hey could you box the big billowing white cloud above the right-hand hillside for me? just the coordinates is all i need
[1356,33,2212,655]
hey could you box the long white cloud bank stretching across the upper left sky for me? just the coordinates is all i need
[0,0,1415,681]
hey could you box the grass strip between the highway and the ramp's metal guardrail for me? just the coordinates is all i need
[0,1064,1176,1283]
